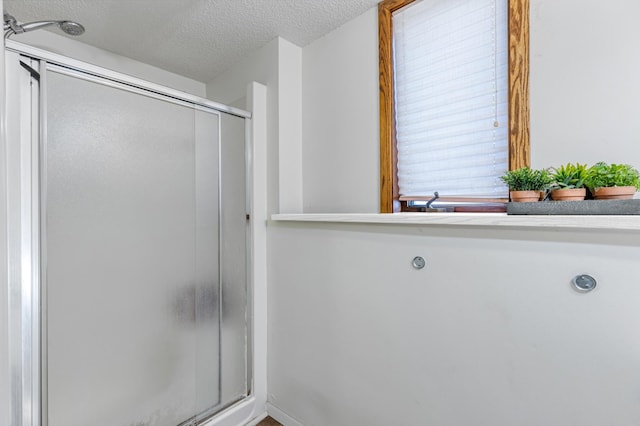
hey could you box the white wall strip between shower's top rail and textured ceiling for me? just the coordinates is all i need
[11,31,206,97]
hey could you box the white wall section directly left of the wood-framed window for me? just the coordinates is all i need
[302,9,380,213]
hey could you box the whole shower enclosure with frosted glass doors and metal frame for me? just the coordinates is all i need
[5,40,252,426]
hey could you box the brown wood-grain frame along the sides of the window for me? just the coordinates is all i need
[378,0,531,213]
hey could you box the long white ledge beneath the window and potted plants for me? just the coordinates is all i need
[271,213,640,232]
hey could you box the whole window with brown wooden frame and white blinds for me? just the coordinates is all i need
[379,0,529,213]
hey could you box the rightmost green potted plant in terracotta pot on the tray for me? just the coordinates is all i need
[584,162,640,200]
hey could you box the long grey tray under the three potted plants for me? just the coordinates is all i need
[507,199,640,215]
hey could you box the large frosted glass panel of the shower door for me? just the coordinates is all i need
[43,72,220,426]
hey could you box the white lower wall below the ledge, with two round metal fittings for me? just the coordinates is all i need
[268,224,640,426]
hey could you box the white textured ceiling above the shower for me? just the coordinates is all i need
[4,0,378,82]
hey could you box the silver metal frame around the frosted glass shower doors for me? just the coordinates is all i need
[3,41,266,426]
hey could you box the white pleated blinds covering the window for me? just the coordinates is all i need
[393,0,509,198]
